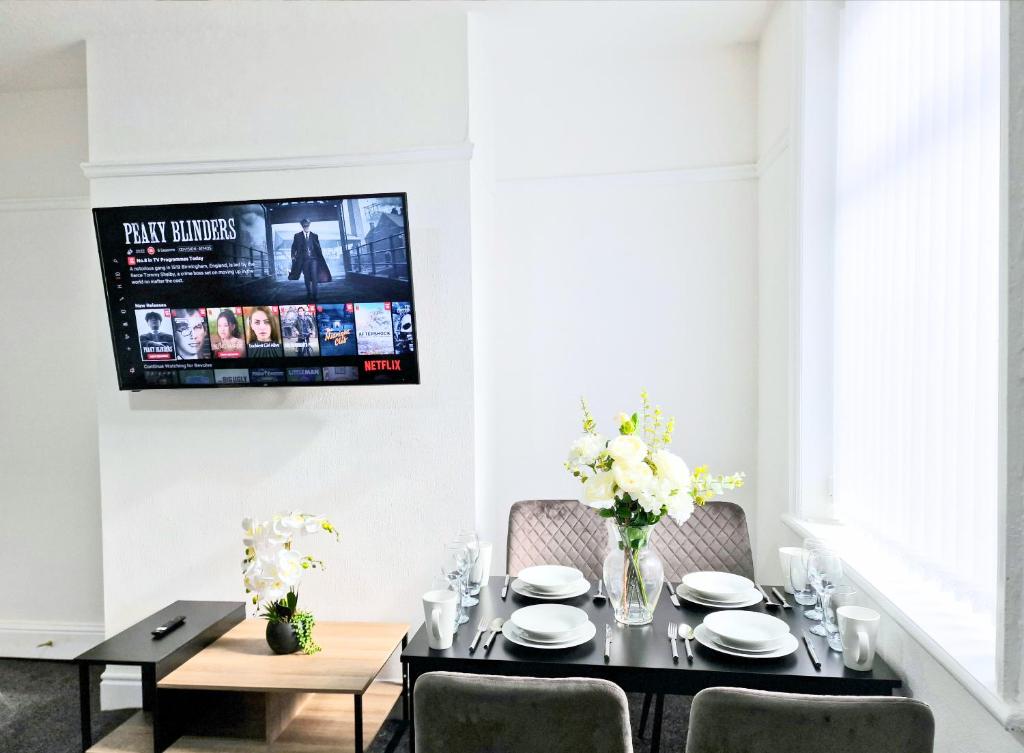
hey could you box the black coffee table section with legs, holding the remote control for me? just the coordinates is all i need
[75,601,246,751]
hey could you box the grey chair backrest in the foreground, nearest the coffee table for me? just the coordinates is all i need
[413,672,630,753]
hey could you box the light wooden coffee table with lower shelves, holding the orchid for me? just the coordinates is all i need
[91,620,409,753]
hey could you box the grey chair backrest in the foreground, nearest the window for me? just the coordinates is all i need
[686,687,935,753]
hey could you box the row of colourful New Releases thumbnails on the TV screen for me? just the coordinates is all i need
[135,301,415,362]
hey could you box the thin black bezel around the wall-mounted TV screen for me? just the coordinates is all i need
[91,191,422,392]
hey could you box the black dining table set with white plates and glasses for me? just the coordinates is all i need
[401,576,902,753]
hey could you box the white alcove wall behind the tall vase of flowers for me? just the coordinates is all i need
[470,8,758,564]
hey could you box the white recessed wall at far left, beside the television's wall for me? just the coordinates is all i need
[0,89,103,659]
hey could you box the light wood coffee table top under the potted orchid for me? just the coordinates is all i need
[158,620,409,695]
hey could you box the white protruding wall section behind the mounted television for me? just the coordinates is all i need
[88,4,473,672]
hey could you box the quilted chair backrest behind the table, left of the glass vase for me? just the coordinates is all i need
[505,499,608,581]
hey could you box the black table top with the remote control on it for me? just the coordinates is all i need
[75,601,245,664]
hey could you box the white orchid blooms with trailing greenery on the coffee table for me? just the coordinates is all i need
[242,512,338,654]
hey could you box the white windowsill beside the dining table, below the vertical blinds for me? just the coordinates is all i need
[782,514,1024,730]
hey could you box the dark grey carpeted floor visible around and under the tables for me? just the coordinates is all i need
[0,659,689,753]
